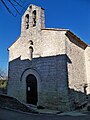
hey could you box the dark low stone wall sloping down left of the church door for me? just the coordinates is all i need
[0,94,38,113]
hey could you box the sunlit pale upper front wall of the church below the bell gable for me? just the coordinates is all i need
[9,29,66,61]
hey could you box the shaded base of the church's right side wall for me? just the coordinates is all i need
[69,88,90,110]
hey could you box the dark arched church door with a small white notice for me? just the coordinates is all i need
[26,74,38,105]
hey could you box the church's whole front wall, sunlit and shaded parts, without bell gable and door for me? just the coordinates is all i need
[8,30,69,111]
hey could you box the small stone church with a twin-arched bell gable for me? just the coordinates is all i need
[8,4,90,111]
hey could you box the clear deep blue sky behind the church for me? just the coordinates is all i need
[0,0,90,70]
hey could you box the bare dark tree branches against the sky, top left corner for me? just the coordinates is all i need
[1,0,30,16]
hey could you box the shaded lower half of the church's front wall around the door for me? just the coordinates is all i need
[8,55,69,110]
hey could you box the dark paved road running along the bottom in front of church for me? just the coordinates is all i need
[0,108,90,120]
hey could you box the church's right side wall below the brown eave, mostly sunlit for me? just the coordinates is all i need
[66,36,87,108]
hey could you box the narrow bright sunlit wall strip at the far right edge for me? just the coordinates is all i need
[85,46,90,94]
